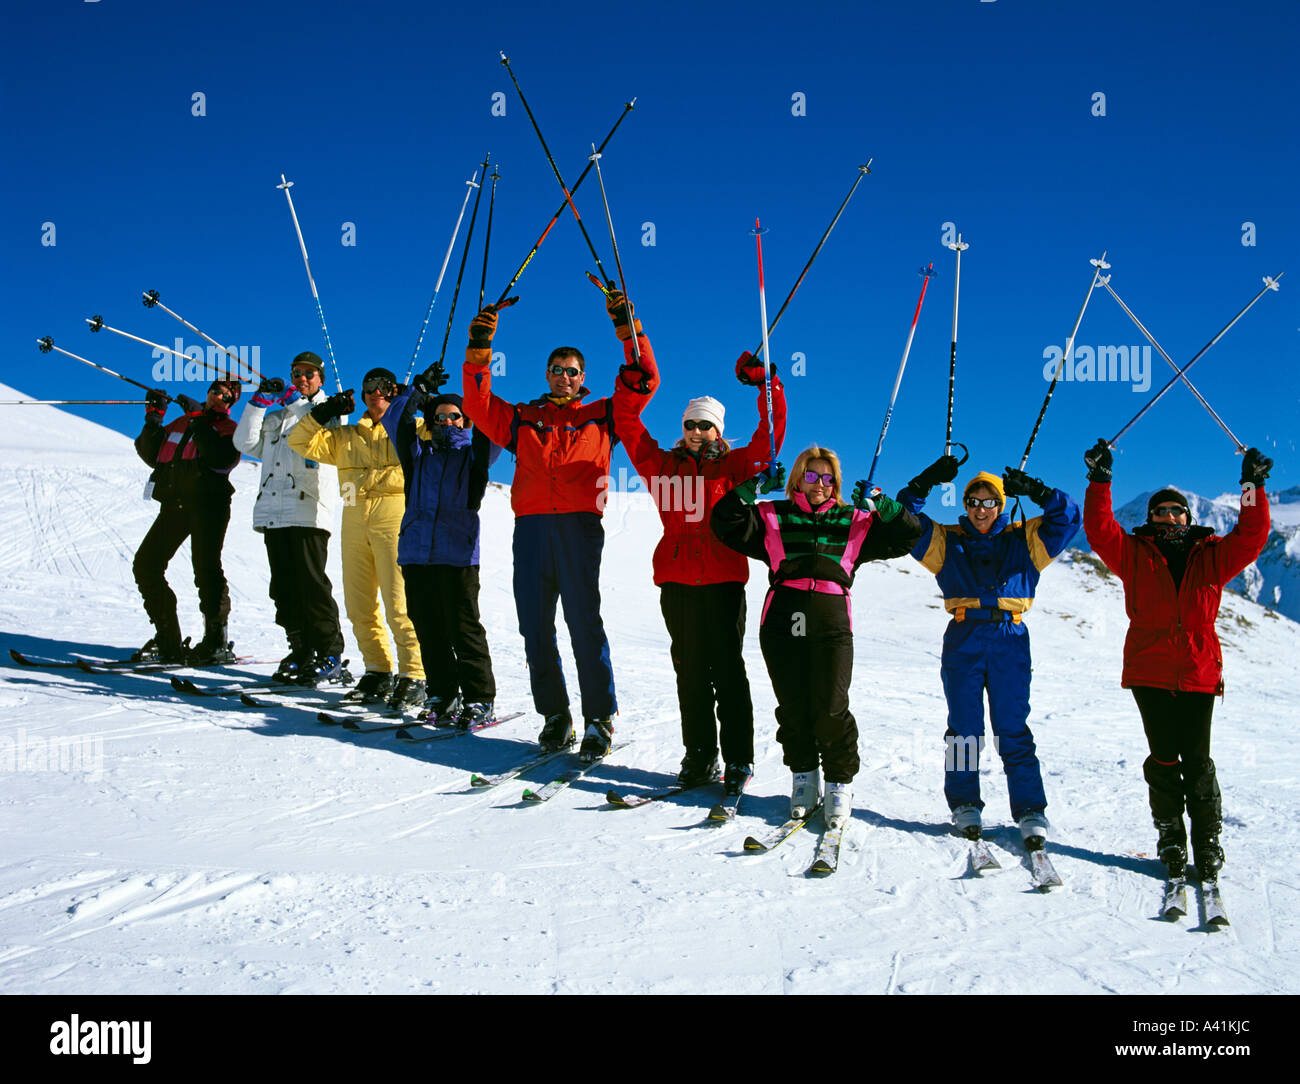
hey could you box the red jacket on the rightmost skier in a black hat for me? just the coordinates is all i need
[1083,482,1269,694]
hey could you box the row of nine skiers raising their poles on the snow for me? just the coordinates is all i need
[135,290,1271,876]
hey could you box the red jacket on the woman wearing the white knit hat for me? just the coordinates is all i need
[614,348,785,586]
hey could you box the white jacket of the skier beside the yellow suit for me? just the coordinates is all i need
[234,387,339,530]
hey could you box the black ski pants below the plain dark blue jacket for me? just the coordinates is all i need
[402,564,497,703]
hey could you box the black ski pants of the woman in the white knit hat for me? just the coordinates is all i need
[659,584,754,764]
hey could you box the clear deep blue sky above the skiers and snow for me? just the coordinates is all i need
[0,0,1300,499]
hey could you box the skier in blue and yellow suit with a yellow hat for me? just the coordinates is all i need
[898,455,1083,844]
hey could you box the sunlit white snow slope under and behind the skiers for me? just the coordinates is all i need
[0,390,1300,994]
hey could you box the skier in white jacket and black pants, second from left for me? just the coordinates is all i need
[234,351,343,685]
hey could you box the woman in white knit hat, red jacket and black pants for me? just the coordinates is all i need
[614,351,785,794]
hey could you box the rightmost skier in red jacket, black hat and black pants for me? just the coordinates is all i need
[1083,441,1273,881]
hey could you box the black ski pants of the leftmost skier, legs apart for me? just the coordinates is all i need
[131,500,230,629]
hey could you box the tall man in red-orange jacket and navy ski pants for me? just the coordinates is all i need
[464,291,654,763]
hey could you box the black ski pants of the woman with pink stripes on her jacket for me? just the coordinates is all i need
[758,586,859,782]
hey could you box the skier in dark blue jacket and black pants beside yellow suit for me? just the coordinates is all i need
[382,365,501,729]
